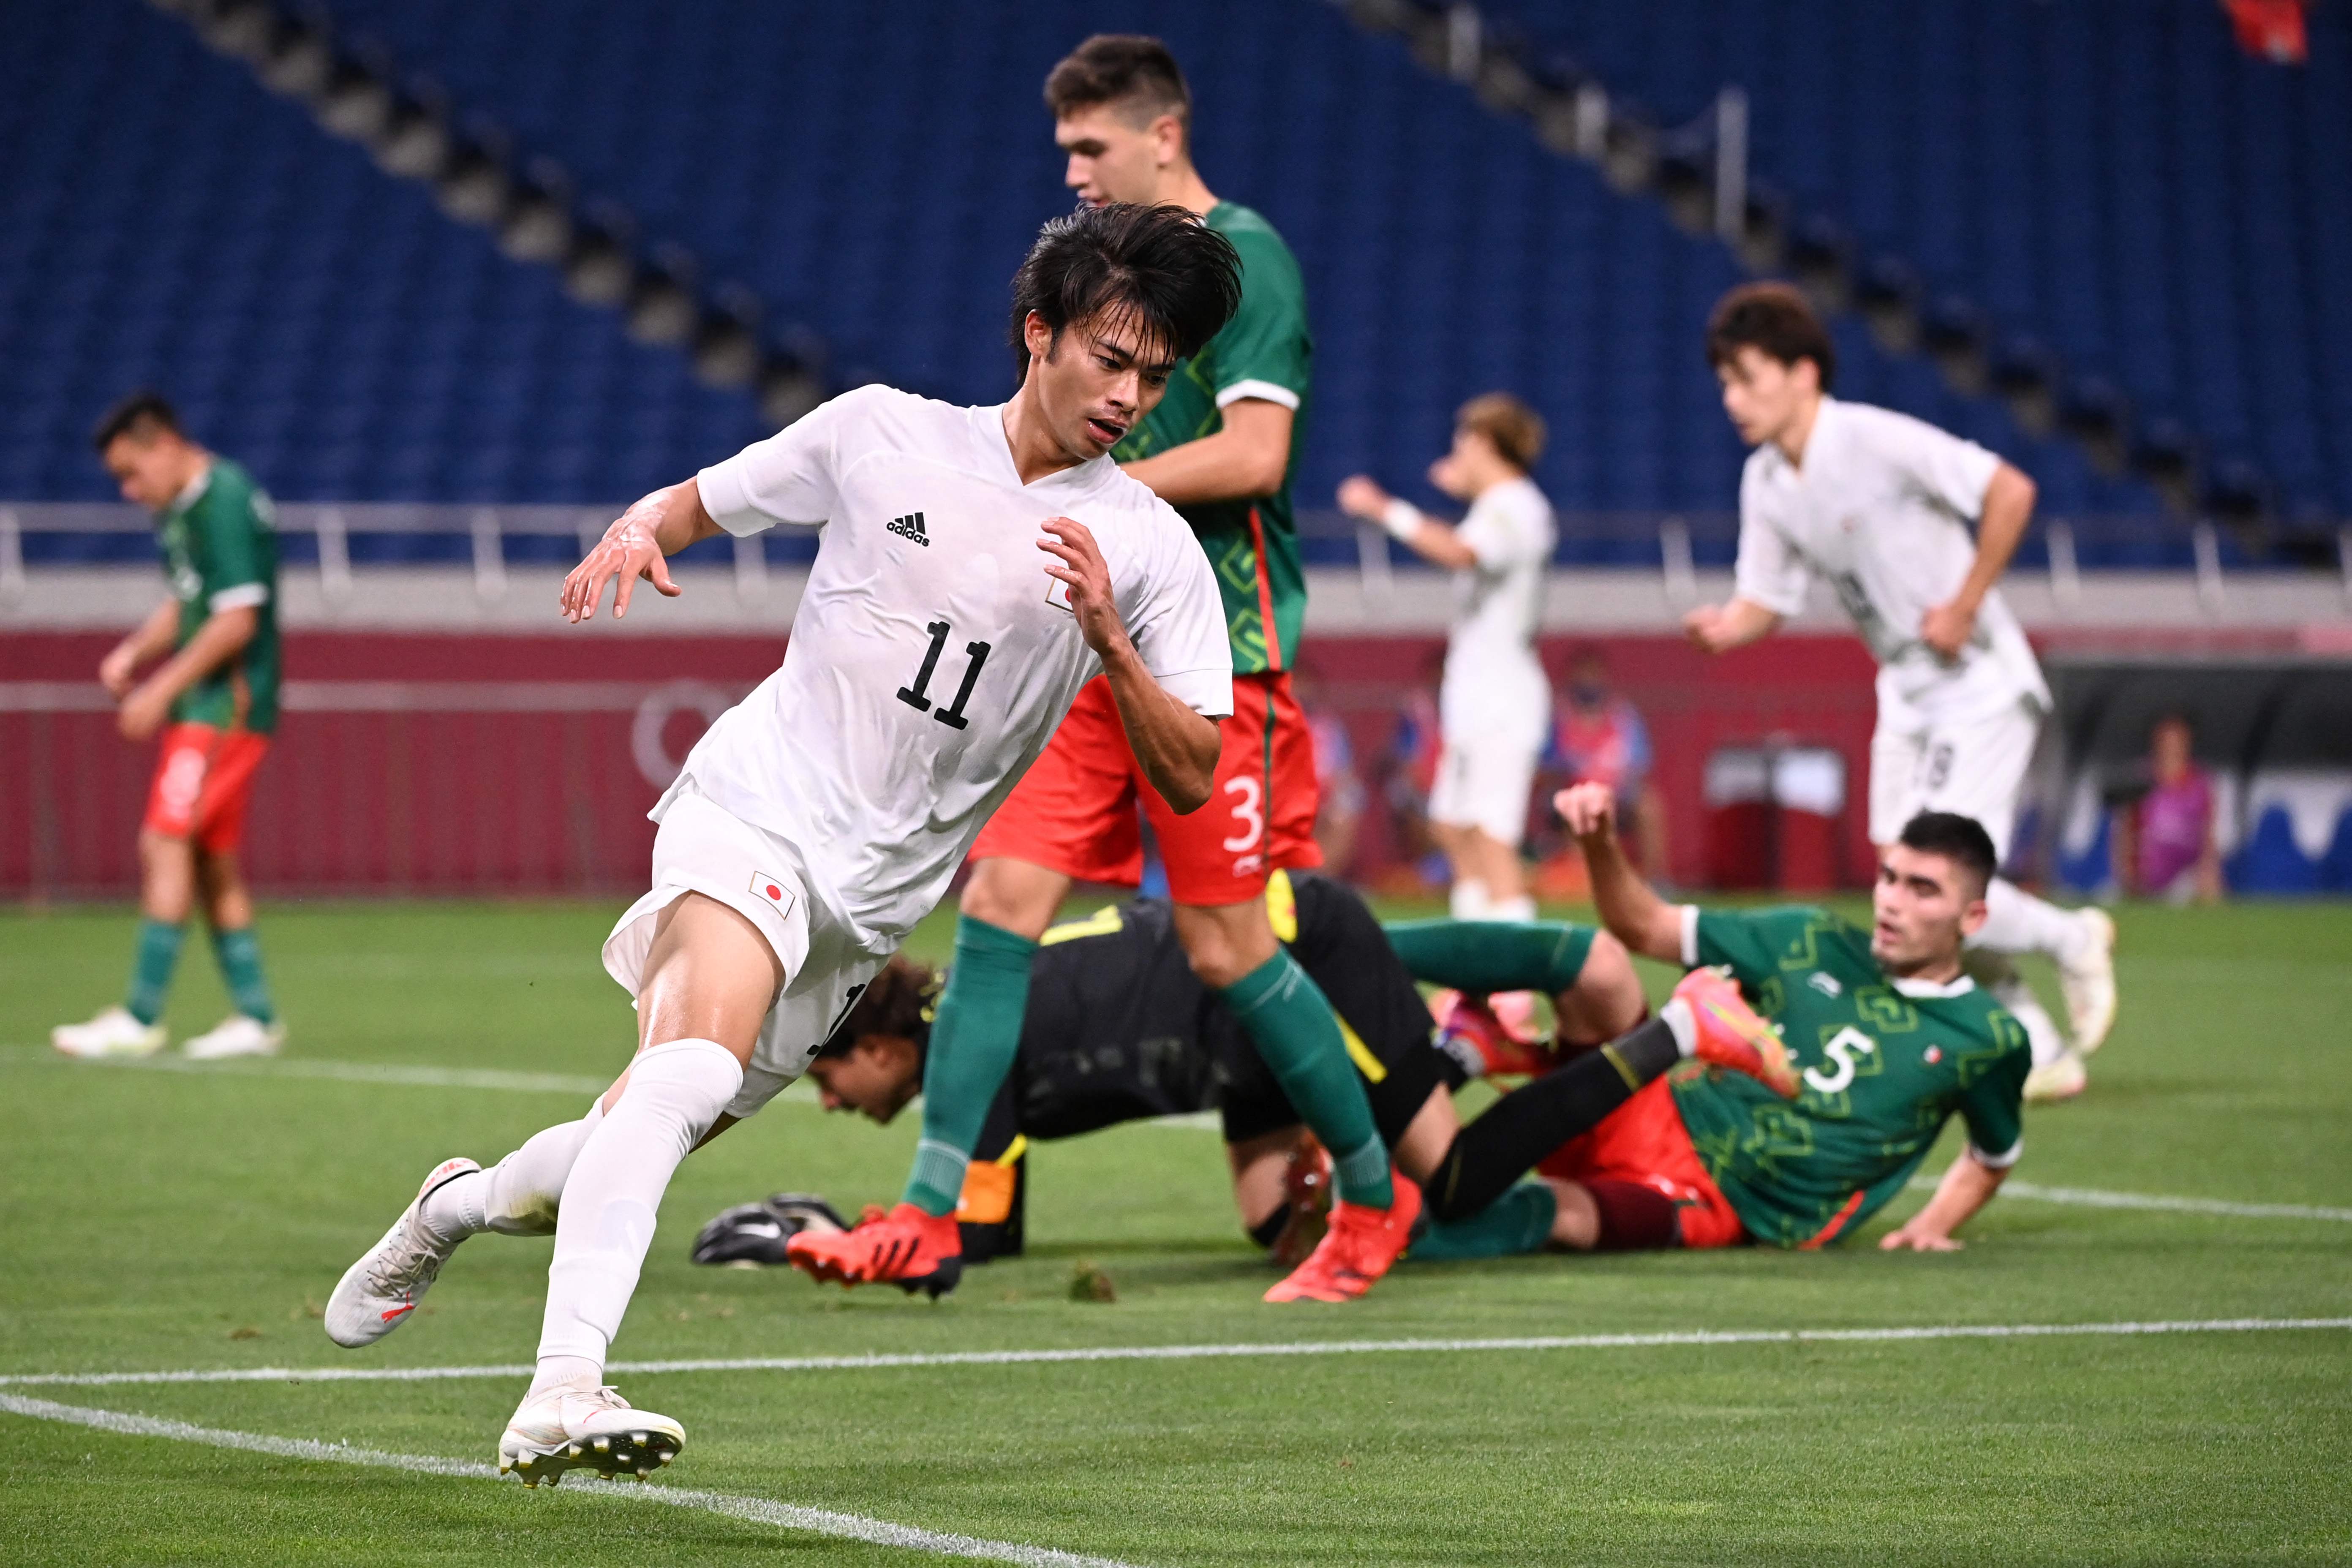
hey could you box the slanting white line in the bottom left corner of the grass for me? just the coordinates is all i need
[0,1394,1129,1568]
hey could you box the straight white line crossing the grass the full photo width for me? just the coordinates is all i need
[0,1317,2352,1399]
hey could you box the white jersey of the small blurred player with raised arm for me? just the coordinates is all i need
[1437,479,1554,740]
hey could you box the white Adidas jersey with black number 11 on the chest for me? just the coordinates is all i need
[656,386,1233,954]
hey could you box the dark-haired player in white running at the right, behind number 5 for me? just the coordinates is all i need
[1684,282,2115,1098]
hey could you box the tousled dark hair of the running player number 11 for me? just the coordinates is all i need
[1011,202,1242,376]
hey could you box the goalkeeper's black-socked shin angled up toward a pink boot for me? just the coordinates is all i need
[1421,999,1696,1225]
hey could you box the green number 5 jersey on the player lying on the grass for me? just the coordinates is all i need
[1670,907,2032,1246]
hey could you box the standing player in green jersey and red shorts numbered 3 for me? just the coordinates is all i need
[818,35,1421,1300]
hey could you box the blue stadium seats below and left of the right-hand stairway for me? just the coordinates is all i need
[0,0,2220,564]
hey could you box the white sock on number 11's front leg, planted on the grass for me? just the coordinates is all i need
[534,1039,743,1389]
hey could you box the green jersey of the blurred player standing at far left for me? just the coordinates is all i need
[155,458,278,736]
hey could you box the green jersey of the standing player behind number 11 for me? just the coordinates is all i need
[1115,202,1315,675]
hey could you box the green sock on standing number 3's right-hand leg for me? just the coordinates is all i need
[1218,947,1397,1209]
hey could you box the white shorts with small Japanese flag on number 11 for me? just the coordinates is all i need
[604,790,885,1119]
